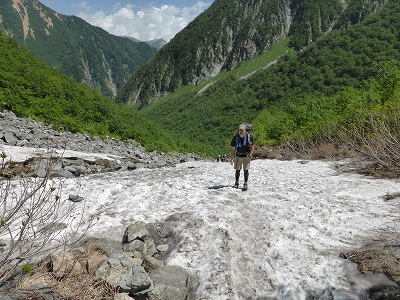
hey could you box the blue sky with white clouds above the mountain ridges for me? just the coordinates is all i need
[40,0,214,42]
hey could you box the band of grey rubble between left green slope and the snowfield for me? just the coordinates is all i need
[0,111,200,177]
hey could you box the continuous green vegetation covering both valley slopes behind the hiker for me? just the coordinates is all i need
[0,1,400,159]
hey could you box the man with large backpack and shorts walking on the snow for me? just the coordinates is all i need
[230,124,254,190]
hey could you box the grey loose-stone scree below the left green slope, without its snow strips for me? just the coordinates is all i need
[0,110,206,177]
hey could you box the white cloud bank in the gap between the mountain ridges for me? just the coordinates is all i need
[78,1,211,42]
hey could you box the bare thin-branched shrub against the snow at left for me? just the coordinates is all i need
[0,152,97,282]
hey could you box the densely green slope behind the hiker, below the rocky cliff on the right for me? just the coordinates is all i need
[139,1,400,157]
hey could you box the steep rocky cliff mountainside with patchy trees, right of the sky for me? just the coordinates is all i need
[116,0,387,107]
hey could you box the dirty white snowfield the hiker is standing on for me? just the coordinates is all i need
[3,146,400,300]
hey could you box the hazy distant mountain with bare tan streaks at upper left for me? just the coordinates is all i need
[0,0,157,98]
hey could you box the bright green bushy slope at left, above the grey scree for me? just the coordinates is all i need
[0,35,198,152]
